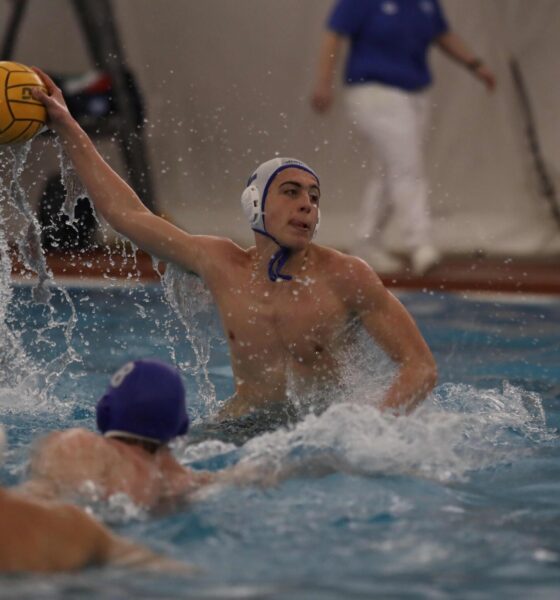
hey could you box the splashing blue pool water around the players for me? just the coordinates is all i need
[0,286,560,599]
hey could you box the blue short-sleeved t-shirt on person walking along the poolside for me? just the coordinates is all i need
[328,0,449,91]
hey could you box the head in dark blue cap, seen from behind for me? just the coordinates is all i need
[97,360,189,445]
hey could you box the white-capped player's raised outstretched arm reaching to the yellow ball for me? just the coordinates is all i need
[32,68,223,274]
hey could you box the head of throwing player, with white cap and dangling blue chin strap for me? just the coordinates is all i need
[241,158,321,281]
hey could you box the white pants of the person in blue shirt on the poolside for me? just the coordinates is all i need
[346,84,430,251]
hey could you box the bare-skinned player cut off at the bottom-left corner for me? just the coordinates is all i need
[0,425,193,574]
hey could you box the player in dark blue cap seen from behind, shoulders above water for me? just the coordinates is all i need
[19,360,272,510]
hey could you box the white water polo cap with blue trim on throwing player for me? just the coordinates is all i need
[241,158,319,235]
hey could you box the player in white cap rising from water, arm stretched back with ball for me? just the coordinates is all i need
[32,69,437,436]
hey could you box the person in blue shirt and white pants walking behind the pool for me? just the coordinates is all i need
[311,0,496,275]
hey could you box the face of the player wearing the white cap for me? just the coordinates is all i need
[265,168,321,249]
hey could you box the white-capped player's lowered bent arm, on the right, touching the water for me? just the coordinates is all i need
[344,258,437,414]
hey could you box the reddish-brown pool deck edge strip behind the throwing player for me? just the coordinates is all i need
[8,249,560,295]
